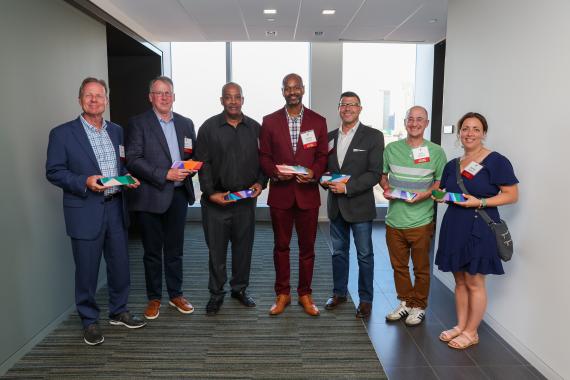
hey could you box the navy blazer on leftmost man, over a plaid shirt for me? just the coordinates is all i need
[46,118,128,240]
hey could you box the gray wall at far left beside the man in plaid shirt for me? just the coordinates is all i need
[0,0,107,374]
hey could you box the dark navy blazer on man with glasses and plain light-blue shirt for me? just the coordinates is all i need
[125,109,196,214]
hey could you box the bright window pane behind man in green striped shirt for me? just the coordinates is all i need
[342,43,416,204]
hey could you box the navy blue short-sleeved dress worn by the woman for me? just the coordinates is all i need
[435,152,519,275]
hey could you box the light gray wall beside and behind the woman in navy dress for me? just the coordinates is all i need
[436,0,570,379]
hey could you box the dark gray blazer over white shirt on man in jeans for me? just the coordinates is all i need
[327,123,384,223]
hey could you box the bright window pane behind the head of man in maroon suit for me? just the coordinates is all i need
[231,42,310,123]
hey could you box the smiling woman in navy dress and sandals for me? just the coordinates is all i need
[435,112,518,349]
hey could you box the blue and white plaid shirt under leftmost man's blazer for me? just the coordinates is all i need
[79,116,121,196]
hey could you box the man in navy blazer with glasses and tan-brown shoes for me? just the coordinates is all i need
[126,76,196,319]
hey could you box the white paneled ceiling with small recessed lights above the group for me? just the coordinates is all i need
[91,0,448,43]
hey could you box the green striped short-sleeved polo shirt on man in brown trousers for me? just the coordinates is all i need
[383,139,447,229]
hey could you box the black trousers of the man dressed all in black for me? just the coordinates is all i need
[201,198,256,297]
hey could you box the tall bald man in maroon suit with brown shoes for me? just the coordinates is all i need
[259,74,327,316]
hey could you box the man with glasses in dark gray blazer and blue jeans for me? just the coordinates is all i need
[323,91,384,318]
